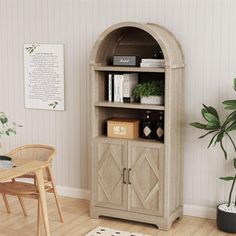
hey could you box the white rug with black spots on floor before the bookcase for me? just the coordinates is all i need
[85,227,150,236]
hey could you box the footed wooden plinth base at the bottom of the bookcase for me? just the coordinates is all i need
[90,207,183,230]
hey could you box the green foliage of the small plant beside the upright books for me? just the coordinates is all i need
[133,80,165,98]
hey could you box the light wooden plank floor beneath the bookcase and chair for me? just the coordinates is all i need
[0,196,235,236]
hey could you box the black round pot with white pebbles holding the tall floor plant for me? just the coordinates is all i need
[216,203,236,233]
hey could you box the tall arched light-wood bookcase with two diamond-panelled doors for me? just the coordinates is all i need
[89,22,184,230]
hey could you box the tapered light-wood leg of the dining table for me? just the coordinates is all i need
[35,169,50,236]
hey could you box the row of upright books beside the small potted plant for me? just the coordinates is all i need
[107,73,138,102]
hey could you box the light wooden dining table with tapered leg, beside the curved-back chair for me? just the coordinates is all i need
[0,158,50,236]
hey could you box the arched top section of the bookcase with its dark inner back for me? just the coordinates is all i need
[90,22,184,68]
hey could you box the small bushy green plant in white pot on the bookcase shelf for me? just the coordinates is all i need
[133,79,165,105]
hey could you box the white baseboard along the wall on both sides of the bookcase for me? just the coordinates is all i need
[57,186,216,219]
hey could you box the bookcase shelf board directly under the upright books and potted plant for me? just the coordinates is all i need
[94,101,165,111]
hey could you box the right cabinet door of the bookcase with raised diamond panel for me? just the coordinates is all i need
[128,141,164,216]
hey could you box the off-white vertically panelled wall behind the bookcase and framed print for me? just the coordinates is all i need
[0,0,236,218]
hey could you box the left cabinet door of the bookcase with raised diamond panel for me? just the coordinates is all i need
[93,138,127,210]
